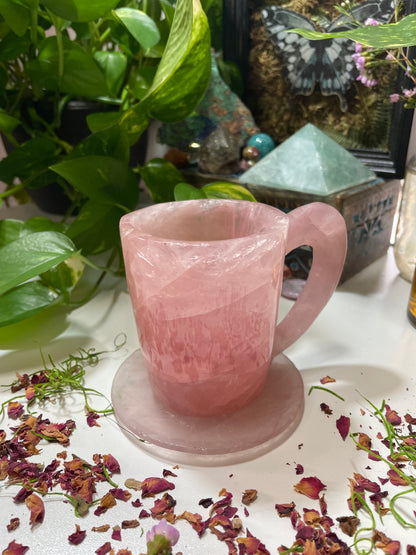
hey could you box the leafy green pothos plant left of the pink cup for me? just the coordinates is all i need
[0,0,255,326]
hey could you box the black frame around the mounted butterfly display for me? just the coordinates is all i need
[223,0,416,179]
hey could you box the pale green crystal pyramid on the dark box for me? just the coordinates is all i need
[239,123,377,196]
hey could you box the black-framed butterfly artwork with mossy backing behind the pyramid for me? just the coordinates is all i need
[223,0,416,179]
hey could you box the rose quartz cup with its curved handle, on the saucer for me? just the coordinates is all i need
[120,199,346,416]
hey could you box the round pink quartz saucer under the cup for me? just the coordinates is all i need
[111,350,304,465]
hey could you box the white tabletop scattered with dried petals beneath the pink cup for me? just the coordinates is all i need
[0,203,416,555]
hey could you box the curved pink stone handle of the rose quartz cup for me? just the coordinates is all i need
[272,202,347,357]
